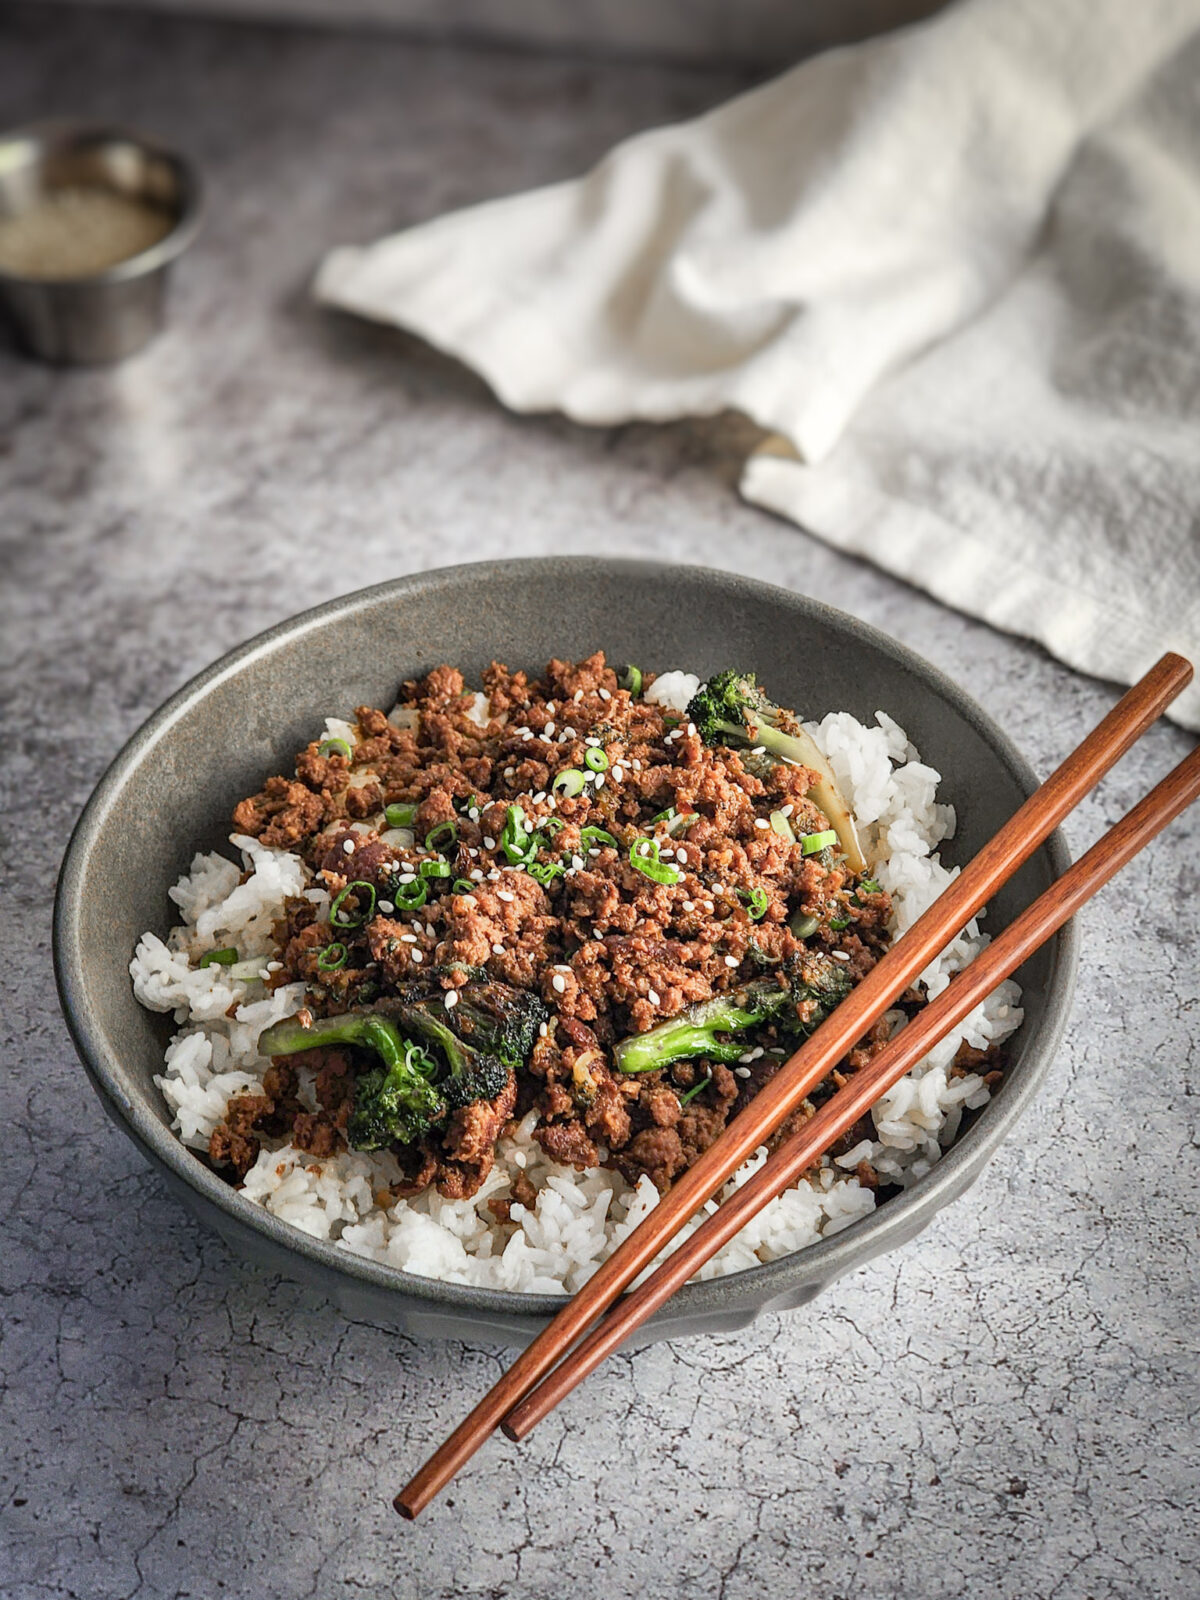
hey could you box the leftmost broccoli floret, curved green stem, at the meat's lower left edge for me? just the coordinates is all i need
[259,1011,446,1150]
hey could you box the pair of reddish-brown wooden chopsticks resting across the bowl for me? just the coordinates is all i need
[394,654,1200,1518]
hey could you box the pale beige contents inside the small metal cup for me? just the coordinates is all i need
[0,184,174,280]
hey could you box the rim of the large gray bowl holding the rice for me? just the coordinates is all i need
[53,555,1078,1325]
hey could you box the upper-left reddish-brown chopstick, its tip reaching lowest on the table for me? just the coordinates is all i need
[394,654,1192,1518]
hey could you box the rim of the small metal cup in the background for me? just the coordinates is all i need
[0,117,205,290]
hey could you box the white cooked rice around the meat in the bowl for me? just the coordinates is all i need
[130,694,1022,1294]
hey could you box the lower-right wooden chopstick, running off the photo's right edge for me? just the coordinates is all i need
[501,746,1200,1438]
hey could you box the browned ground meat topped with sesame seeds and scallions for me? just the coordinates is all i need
[210,653,921,1216]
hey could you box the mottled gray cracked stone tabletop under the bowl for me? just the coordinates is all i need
[0,10,1200,1600]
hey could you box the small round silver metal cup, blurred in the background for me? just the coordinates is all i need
[0,120,200,365]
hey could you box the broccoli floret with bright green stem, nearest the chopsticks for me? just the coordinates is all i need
[613,955,851,1072]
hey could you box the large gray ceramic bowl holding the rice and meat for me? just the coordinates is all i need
[54,558,1077,1342]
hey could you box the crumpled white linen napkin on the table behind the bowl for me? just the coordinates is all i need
[315,0,1200,726]
